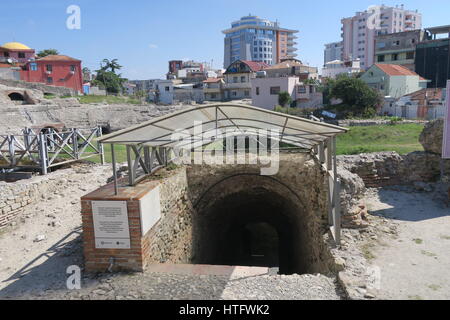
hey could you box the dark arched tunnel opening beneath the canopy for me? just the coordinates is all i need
[193,175,320,274]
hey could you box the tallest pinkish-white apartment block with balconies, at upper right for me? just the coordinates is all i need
[341,5,422,70]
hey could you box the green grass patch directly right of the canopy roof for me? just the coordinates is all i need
[337,123,424,155]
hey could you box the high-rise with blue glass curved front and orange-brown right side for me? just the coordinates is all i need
[223,16,298,68]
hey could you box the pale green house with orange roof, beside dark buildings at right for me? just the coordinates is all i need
[361,64,429,99]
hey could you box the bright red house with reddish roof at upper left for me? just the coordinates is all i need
[21,55,83,93]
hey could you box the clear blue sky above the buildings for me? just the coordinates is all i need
[0,0,450,80]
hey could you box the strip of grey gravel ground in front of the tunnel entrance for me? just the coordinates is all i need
[12,273,342,300]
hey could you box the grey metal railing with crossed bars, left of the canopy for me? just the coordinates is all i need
[0,127,105,175]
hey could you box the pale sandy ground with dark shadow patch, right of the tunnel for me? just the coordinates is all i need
[367,189,450,300]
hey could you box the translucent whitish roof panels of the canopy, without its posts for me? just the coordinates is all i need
[99,103,347,149]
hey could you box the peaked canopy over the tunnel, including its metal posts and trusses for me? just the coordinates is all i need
[98,103,348,244]
